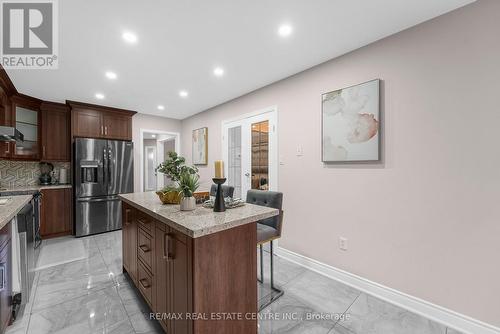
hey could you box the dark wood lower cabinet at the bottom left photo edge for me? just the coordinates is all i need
[0,223,12,333]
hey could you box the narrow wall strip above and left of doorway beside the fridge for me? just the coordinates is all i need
[132,114,182,191]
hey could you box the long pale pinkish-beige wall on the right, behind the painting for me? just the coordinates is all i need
[182,0,500,326]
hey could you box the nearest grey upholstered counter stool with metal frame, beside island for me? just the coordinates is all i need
[247,190,283,311]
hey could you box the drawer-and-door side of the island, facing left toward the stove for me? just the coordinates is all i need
[122,203,193,334]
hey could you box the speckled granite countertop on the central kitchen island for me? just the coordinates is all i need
[119,192,279,238]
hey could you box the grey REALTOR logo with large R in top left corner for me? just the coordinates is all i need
[1,0,58,69]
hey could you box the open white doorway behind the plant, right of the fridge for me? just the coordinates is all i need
[140,129,180,191]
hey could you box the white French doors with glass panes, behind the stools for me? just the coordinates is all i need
[222,108,278,200]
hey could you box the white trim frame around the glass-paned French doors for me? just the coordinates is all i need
[221,105,279,197]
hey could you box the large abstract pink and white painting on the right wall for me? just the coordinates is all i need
[321,79,380,162]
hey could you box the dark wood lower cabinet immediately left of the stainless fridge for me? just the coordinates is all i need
[40,188,73,238]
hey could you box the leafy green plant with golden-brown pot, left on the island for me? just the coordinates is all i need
[155,151,198,204]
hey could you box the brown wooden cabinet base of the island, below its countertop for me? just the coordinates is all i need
[122,202,257,334]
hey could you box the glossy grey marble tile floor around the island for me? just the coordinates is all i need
[7,231,460,334]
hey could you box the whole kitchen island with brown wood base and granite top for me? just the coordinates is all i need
[120,192,279,334]
